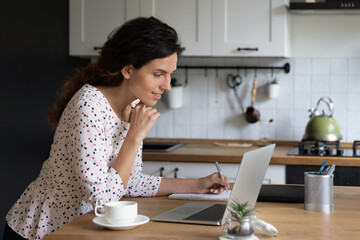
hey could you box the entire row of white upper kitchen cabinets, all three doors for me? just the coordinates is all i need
[70,0,289,57]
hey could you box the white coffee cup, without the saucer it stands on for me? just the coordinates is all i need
[95,201,138,225]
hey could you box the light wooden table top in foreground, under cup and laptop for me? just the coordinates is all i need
[45,186,360,240]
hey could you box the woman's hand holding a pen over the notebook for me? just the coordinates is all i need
[198,172,229,194]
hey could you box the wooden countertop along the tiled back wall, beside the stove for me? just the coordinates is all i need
[143,139,360,167]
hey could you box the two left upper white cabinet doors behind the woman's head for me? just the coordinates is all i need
[70,0,211,56]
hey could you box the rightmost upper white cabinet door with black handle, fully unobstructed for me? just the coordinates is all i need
[212,0,287,56]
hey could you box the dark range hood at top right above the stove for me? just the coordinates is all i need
[287,0,360,14]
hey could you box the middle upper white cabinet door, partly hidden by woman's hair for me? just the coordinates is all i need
[140,0,211,56]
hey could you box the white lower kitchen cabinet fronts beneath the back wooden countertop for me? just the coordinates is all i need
[143,161,285,184]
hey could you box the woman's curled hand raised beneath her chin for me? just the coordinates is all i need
[127,102,160,142]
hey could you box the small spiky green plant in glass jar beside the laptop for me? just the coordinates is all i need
[225,201,254,239]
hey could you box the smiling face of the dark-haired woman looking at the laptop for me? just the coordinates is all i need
[129,53,177,106]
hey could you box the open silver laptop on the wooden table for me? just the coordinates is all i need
[151,144,275,225]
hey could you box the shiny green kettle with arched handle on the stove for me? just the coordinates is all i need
[303,97,342,141]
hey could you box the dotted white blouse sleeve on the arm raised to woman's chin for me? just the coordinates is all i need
[68,97,124,206]
